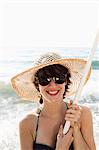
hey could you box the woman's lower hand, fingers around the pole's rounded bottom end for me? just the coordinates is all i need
[56,125,73,150]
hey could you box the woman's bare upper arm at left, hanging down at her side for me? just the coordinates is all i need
[19,115,33,150]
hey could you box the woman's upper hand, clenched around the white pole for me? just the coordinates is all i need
[65,101,82,127]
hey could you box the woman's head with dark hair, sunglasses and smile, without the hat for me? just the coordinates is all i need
[34,64,70,102]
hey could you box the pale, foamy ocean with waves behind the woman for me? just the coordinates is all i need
[0,48,99,150]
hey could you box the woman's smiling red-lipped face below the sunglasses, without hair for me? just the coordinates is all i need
[39,77,66,102]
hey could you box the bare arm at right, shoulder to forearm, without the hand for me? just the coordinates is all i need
[74,107,96,150]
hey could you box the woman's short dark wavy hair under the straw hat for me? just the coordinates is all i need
[33,64,71,103]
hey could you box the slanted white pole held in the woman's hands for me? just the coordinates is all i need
[63,31,99,134]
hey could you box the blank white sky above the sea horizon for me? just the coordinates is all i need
[0,0,99,51]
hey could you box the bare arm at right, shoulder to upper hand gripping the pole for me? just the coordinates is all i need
[66,105,96,150]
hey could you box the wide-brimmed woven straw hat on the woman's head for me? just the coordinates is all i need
[11,53,91,101]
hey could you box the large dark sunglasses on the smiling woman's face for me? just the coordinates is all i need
[38,75,66,86]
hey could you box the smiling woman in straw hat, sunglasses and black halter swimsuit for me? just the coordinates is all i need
[11,53,96,150]
